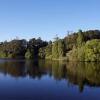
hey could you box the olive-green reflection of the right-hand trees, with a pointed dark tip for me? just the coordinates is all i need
[67,62,100,92]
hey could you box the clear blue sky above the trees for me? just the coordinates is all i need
[0,0,100,41]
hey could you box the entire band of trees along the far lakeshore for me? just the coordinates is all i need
[0,30,100,61]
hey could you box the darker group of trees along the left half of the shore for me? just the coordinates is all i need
[0,38,48,59]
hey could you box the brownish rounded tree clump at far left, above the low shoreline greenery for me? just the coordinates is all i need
[0,39,27,58]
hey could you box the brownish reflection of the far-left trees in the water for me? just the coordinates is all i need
[0,61,25,77]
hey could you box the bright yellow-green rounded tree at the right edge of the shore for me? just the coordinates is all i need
[85,39,100,61]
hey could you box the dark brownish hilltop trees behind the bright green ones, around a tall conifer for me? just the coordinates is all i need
[64,30,100,52]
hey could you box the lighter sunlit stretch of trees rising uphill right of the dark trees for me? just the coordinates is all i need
[39,30,100,61]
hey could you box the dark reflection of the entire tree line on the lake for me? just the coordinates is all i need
[0,60,100,92]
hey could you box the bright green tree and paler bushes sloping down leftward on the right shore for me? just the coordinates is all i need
[67,39,100,61]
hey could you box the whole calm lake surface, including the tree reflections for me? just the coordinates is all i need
[0,60,100,100]
